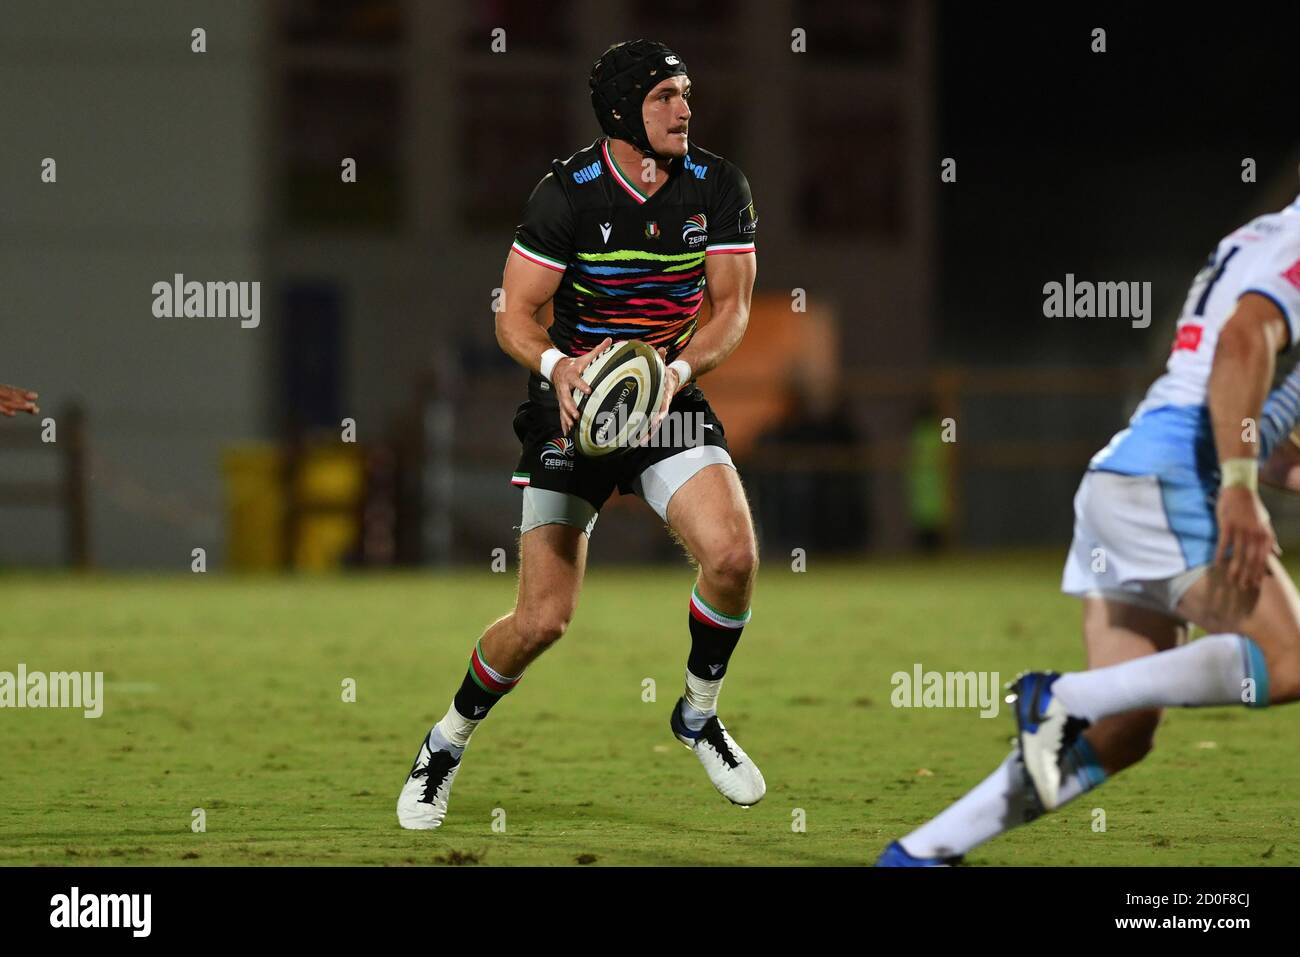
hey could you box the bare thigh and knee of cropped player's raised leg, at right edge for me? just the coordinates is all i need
[1178,555,1300,703]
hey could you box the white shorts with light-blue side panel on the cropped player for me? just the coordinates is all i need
[1061,471,1217,618]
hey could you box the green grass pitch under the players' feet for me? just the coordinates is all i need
[0,555,1300,865]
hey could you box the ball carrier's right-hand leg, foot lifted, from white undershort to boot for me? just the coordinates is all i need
[638,455,767,806]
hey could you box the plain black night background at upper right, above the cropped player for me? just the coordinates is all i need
[936,3,1300,364]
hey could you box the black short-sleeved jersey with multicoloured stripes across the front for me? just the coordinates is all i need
[511,137,758,399]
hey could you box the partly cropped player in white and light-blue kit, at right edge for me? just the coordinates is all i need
[878,191,1300,866]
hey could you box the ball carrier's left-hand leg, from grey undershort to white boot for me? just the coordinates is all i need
[398,488,597,830]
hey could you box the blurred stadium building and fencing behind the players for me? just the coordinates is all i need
[0,0,1295,568]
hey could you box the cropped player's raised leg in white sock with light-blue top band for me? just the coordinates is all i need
[1022,557,1300,806]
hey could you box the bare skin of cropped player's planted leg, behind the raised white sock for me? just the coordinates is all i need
[1083,597,1186,774]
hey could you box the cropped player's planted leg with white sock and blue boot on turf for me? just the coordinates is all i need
[878,596,1186,867]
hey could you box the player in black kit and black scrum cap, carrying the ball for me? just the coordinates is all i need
[398,40,766,830]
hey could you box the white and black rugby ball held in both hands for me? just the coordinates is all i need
[573,339,666,458]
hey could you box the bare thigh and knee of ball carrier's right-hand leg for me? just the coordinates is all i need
[666,463,758,572]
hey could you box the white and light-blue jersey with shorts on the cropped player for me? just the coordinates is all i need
[1062,199,1300,611]
